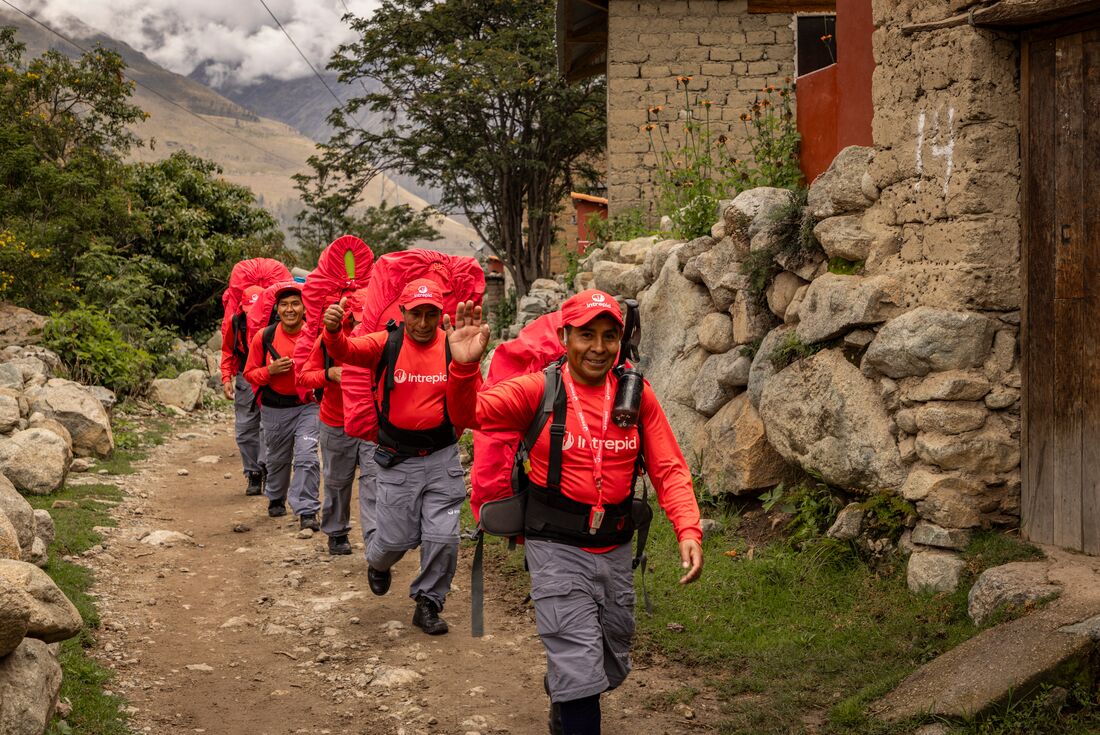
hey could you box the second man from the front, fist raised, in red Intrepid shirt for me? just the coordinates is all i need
[323,278,466,635]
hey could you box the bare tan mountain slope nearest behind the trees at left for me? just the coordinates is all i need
[0,10,480,254]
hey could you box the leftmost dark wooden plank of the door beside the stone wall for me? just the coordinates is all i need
[1021,40,1055,544]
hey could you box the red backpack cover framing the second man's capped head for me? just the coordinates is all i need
[340,249,485,440]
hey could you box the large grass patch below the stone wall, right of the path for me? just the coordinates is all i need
[635,498,1086,735]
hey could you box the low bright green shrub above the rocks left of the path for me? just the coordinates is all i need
[42,305,153,395]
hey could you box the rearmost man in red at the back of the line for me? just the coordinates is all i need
[221,286,264,495]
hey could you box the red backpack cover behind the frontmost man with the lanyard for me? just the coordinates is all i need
[470,311,565,519]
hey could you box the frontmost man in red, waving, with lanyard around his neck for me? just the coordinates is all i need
[447,289,703,735]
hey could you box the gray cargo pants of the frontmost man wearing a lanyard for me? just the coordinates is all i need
[526,539,635,702]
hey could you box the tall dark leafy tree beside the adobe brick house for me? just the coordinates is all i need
[322,0,606,295]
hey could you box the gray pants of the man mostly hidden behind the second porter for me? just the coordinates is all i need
[320,421,378,542]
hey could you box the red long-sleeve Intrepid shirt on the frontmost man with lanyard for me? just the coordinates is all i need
[447,362,703,541]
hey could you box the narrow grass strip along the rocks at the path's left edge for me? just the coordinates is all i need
[28,485,131,735]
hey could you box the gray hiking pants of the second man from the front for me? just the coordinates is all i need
[366,445,466,610]
